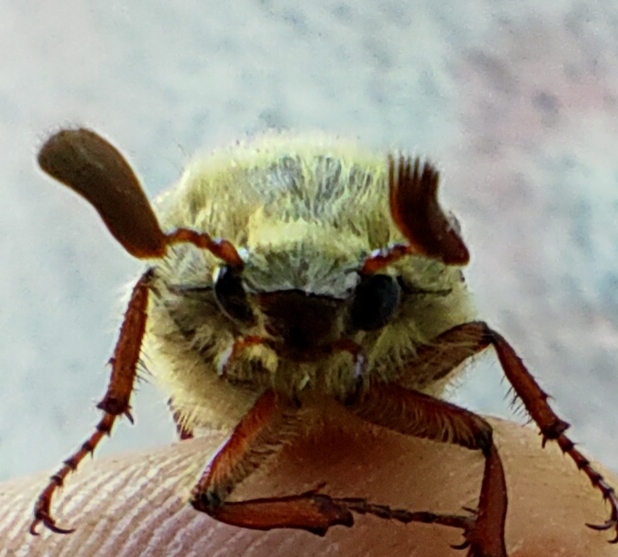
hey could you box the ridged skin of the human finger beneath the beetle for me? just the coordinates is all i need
[0,414,618,557]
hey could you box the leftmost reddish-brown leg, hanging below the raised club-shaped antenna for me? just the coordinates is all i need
[30,271,151,535]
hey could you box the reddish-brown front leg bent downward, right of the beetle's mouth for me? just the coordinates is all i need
[344,383,507,557]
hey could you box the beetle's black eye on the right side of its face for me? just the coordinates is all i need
[351,275,401,331]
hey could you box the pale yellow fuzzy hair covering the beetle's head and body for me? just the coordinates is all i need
[144,133,473,429]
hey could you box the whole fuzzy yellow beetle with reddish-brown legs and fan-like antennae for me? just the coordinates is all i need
[30,128,618,557]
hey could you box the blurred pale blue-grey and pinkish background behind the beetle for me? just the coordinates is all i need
[0,0,618,479]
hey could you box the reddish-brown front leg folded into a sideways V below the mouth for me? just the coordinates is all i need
[191,391,474,535]
